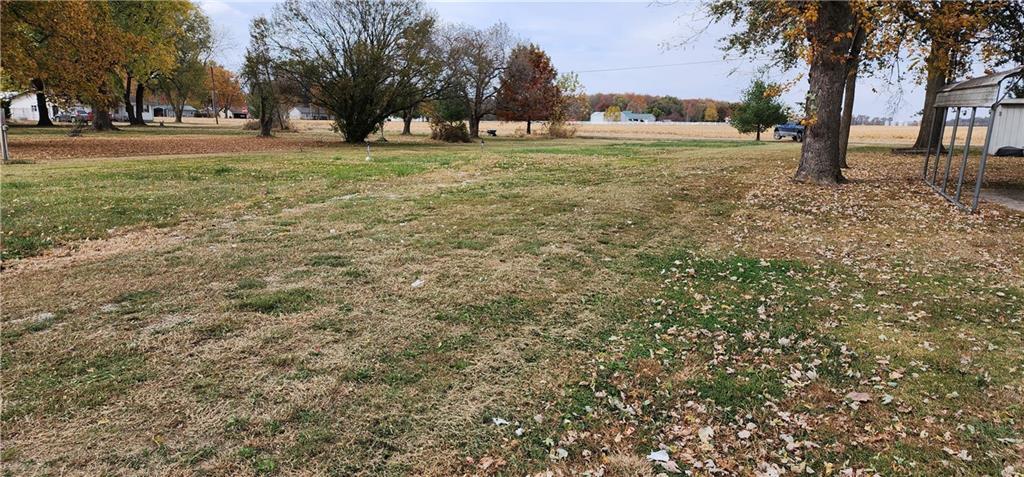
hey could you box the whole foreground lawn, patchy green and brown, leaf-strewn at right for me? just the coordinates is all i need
[0,132,1024,476]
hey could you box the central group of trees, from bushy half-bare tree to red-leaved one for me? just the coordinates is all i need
[242,0,586,143]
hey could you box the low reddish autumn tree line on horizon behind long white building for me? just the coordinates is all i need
[580,93,737,122]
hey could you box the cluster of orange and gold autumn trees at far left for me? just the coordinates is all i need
[0,0,244,130]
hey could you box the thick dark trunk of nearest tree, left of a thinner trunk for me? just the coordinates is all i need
[795,2,853,185]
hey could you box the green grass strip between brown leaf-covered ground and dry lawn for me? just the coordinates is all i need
[0,150,465,260]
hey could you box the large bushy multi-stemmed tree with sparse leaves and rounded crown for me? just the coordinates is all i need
[271,0,443,142]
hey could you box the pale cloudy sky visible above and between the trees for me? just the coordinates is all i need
[200,0,950,121]
